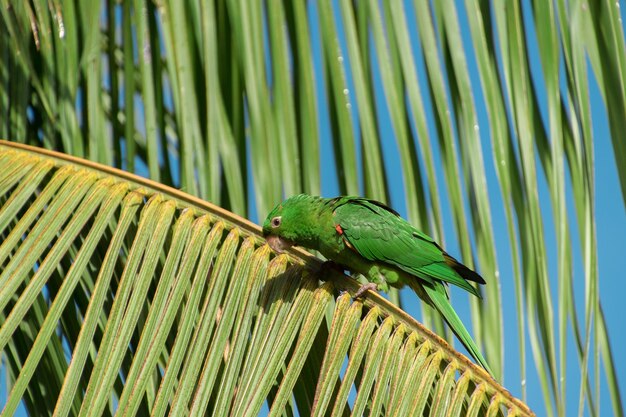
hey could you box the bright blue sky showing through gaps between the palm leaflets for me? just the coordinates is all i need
[0,0,626,416]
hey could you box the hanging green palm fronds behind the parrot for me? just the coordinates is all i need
[0,0,626,415]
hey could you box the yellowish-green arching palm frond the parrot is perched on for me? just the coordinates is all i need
[0,142,532,417]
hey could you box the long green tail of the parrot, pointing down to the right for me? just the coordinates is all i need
[409,281,493,375]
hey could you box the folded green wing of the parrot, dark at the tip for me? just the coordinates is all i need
[334,198,484,297]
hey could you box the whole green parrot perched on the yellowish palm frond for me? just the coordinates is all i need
[263,194,492,374]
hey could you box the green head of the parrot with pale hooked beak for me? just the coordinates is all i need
[263,194,320,253]
